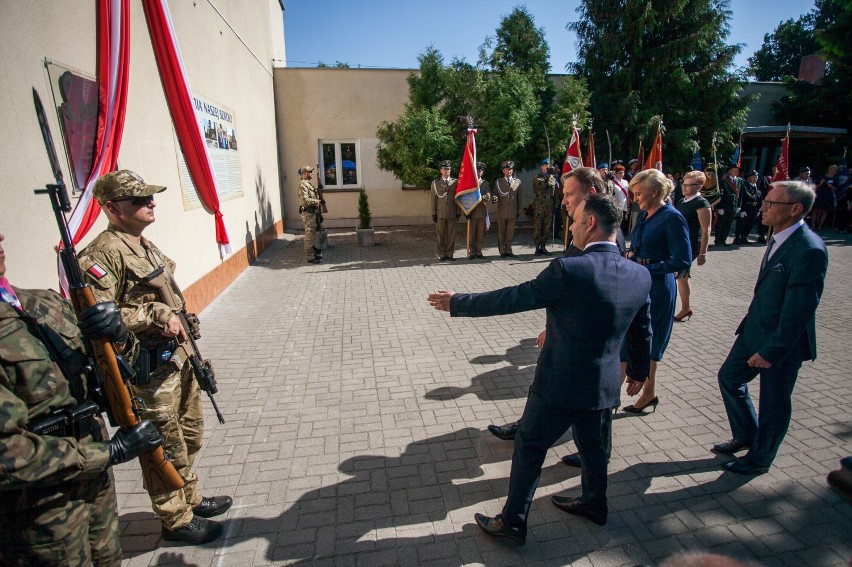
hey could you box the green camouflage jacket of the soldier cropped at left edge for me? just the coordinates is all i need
[0,289,109,492]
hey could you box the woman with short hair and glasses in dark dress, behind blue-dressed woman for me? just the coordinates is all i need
[674,171,713,322]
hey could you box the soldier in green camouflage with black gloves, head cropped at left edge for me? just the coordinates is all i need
[0,230,163,566]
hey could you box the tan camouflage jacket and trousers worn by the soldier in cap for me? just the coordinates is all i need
[80,225,204,531]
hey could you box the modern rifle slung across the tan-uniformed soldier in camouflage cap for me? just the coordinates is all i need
[142,266,225,424]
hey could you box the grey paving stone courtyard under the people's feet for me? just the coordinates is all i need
[116,228,852,567]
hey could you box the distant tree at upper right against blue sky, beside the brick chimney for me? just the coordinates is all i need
[748,14,819,81]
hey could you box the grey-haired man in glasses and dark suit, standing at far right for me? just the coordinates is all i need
[713,181,828,474]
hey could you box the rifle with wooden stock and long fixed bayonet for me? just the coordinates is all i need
[33,89,184,494]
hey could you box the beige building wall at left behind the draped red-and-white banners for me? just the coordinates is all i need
[0,0,284,308]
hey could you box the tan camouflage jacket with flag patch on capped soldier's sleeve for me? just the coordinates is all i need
[80,224,183,339]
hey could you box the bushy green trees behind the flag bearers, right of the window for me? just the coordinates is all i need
[376,7,589,187]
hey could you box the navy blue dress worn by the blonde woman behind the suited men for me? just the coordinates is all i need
[630,203,692,361]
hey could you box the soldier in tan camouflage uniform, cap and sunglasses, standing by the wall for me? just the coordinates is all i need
[80,170,232,543]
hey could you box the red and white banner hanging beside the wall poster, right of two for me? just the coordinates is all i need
[142,0,232,256]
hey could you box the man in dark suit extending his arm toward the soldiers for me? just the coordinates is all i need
[429,195,651,543]
